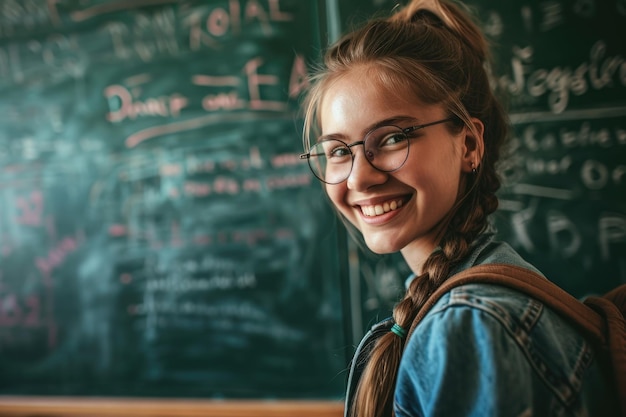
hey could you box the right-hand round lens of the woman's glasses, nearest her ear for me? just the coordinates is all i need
[365,126,409,172]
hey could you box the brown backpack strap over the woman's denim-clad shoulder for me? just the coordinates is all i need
[407,264,606,344]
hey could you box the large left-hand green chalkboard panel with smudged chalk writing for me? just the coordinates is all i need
[0,0,347,398]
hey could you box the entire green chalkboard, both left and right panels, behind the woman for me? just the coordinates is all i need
[0,0,626,398]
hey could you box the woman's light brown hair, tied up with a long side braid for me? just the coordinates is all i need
[303,0,508,417]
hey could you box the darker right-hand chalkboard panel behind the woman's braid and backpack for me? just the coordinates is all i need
[335,0,626,337]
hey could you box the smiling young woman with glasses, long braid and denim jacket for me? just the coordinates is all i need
[303,0,610,417]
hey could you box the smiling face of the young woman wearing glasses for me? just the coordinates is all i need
[319,69,471,270]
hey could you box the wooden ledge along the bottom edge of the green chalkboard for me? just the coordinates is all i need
[0,397,343,417]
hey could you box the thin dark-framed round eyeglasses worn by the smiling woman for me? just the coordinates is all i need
[300,117,453,184]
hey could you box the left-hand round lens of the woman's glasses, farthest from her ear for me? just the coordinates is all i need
[309,139,352,184]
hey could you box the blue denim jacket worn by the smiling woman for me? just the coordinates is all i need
[345,233,611,417]
